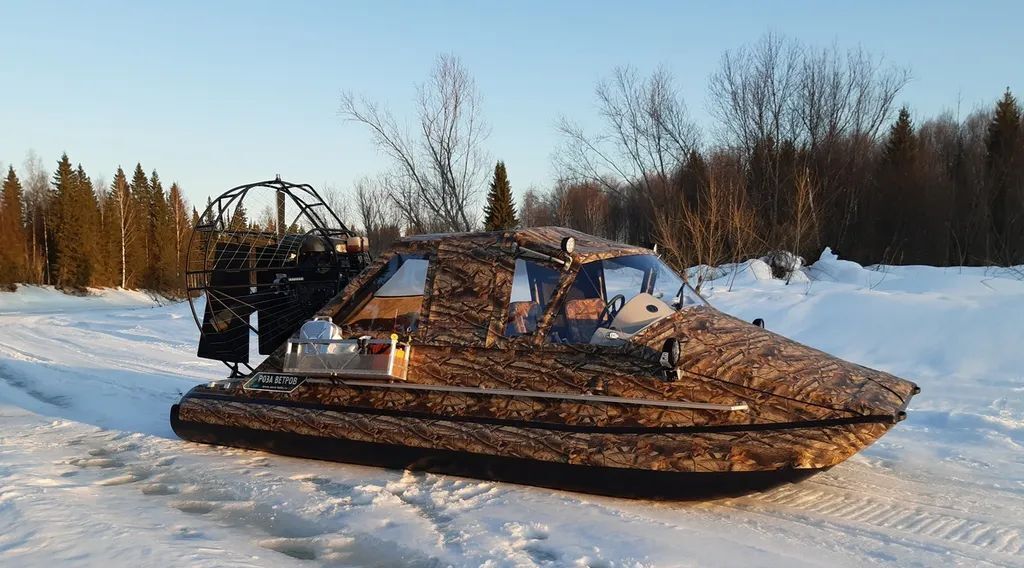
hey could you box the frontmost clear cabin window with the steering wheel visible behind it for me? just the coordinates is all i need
[549,255,683,343]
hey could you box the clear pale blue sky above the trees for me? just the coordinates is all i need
[0,1,1024,208]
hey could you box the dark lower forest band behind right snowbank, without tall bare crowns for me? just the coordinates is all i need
[521,85,1024,267]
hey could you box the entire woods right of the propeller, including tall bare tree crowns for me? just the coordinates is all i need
[341,34,1024,267]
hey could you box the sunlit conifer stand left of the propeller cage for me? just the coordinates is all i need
[0,152,192,296]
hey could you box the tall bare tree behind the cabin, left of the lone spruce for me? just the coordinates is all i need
[341,55,489,232]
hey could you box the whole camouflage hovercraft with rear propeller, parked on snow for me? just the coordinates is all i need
[171,180,920,498]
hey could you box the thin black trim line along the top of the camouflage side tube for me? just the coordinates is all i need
[182,393,898,434]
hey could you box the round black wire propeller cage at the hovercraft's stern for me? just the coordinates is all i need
[185,178,370,374]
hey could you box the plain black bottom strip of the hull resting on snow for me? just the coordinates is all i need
[171,404,827,500]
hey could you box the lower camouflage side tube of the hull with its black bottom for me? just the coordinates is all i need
[171,378,909,498]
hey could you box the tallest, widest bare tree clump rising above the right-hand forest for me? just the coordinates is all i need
[709,34,909,245]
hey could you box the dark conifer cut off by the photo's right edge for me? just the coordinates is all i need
[985,89,1024,263]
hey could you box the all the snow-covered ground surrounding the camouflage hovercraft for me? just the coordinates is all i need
[0,255,1024,568]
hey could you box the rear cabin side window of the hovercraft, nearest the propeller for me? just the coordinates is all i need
[344,255,428,333]
